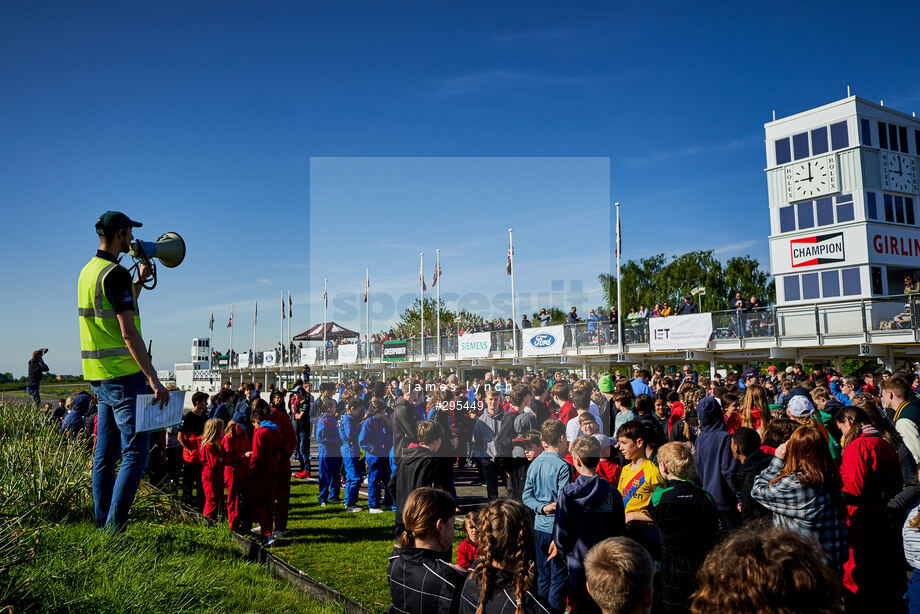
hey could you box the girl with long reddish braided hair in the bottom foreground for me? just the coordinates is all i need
[460,499,550,614]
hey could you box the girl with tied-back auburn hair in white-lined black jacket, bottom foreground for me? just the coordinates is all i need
[387,488,465,614]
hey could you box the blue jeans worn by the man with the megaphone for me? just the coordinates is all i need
[93,373,150,531]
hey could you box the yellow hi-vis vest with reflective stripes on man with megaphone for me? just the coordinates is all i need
[77,256,141,380]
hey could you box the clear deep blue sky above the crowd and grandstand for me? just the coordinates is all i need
[0,2,920,375]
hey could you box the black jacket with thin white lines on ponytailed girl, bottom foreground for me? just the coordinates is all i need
[387,548,466,614]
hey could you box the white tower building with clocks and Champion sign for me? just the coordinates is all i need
[764,96,920,305]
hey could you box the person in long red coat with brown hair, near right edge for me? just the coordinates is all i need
[835,405,906,612]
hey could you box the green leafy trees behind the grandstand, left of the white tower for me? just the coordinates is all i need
[599,250,775,315]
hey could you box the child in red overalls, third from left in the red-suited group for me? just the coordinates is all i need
[247,399,282,546]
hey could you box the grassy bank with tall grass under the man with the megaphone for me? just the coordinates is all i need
[0,405,341,614]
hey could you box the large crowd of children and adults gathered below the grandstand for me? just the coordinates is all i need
[45,364,920,612]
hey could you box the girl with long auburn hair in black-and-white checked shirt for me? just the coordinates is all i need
[751,427,848,569]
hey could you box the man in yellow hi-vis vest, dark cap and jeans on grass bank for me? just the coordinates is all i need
[77,211,169,531]
